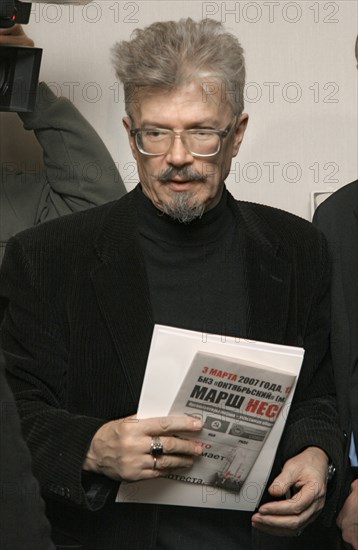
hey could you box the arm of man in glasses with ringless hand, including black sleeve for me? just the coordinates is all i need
[252,234,345,536]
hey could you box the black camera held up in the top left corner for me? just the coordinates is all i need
[0,0,42,112]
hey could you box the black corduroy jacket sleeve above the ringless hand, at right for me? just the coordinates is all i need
[272,236,346,524]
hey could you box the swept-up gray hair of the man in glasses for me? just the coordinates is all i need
[112,18,245,116]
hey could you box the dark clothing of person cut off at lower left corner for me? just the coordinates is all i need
[0,354,55,550]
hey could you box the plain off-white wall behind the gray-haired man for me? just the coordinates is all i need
[0,0,358,218]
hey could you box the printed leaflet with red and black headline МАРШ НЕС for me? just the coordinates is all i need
[167,352,295,491]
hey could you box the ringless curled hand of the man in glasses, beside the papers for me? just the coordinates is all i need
[252,447,328,537]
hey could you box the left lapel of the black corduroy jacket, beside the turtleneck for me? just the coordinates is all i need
[91,193,153,410]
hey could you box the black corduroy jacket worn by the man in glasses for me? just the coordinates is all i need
[0,193,343,550]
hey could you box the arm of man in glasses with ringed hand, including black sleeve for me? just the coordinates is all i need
[0,236,201,510]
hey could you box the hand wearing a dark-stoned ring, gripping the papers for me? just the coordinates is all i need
[83,416,202,481]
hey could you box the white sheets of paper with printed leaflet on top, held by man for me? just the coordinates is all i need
[117,325,304,511]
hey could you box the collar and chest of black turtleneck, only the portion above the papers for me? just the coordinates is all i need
[137,187,245,336]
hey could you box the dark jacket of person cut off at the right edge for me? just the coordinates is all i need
[313,180,358,470]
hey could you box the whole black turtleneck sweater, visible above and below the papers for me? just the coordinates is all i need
[136,187,251,550]
